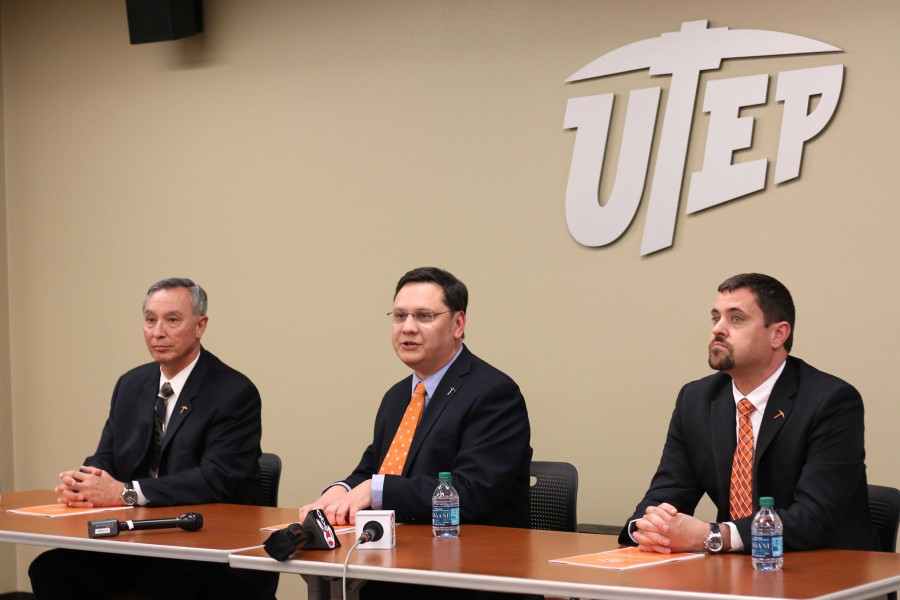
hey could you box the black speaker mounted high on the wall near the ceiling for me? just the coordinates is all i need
[125,0,203,44]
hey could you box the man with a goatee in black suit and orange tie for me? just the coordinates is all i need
[619,273,879,553]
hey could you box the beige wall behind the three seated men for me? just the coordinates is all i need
[0,0,900,591]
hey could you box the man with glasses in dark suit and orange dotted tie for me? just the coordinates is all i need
[300,267,531,598]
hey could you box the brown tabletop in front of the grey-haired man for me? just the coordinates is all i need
[0,490,298,563]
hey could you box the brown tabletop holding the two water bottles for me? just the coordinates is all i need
[229,525,900,600]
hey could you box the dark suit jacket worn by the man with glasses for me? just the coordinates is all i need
[345,347,531,527]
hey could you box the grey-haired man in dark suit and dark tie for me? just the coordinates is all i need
[29,279,277,599]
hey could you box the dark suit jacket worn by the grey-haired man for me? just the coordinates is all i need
[84,349,262,506]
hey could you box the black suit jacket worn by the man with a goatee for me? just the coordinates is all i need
[619,357,880,552]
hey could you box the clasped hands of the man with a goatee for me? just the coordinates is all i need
[631,502,709,554]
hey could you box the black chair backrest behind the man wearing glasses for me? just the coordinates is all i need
[530,460,578,531]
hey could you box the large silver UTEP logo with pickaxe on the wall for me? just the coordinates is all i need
[564,21,844,256]
